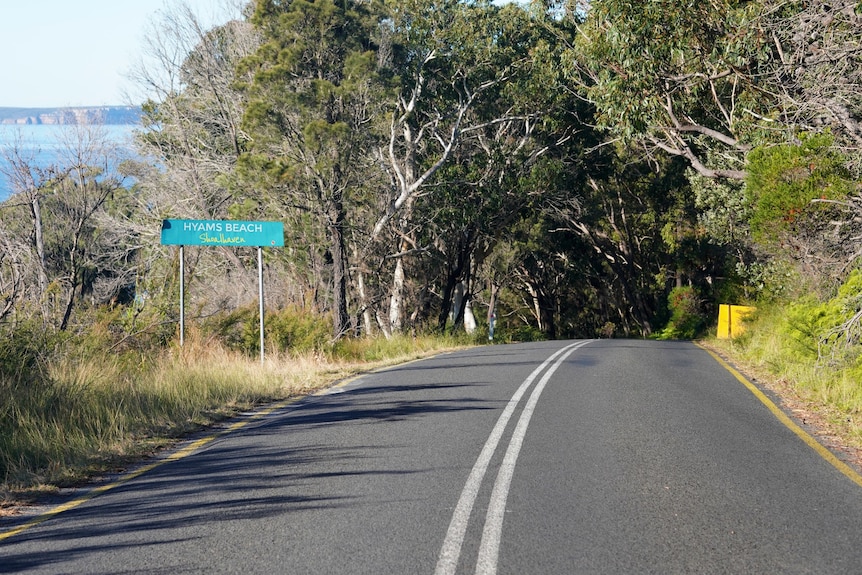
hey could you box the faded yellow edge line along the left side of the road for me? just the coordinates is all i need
[0,397,302,541]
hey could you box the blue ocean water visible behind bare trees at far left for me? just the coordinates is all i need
[0,124,138,201]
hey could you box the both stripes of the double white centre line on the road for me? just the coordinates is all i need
[434,341,590,575]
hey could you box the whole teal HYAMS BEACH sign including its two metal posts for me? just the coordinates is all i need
[161,220,284,363]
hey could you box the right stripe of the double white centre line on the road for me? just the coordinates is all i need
[476,341,589,575]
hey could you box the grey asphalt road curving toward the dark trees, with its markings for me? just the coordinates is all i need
[0,340,862,575]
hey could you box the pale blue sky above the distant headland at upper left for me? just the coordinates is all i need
[0,0,236,108]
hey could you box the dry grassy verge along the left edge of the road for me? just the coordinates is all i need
[0,328,472,513]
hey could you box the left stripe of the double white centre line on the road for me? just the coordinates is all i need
[434,342,588,575]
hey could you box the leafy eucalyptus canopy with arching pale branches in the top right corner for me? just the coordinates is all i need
[570,0,862,176]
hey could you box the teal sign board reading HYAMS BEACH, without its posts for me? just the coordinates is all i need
[162,220,284,247]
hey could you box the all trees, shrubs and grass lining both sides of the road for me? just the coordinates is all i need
[0,0,862,504]
